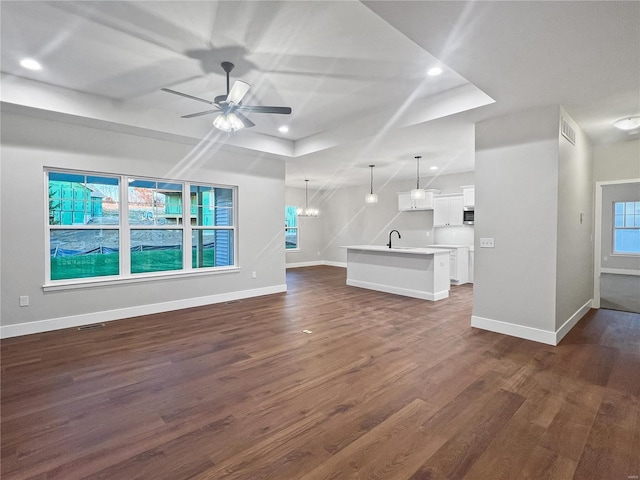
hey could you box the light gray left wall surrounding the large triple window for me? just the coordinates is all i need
[0,112,286,336]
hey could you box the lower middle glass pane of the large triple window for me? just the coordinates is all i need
[131,229,183,273]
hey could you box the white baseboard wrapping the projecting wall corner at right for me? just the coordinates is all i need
[471,300,593,346]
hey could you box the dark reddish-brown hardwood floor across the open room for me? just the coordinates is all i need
[0,267,640,480]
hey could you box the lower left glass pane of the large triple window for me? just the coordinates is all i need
[49,229,120,280]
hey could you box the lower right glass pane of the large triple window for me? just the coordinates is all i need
[191,229,234,268]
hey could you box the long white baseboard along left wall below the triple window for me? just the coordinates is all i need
[0,284,287,338]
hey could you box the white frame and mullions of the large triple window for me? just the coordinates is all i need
[43,167,240,291]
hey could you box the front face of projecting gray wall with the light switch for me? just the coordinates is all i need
[473,107,559,331]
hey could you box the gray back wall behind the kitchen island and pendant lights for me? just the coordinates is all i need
[286,172,474,265]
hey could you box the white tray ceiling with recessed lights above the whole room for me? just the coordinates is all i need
[0,0,640,188]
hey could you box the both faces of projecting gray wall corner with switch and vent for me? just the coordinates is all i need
[473,105,593,341]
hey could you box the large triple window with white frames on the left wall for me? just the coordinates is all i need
[46,171,235,281]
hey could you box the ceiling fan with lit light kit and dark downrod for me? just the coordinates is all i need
[162,62,291,132]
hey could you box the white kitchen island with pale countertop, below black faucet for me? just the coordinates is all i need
[343,245,450,301]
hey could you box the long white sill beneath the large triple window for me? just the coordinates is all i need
[42,267,241,292]
